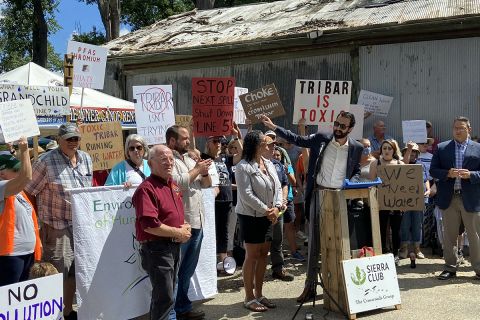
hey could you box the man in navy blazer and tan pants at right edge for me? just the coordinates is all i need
[430,117,480,280]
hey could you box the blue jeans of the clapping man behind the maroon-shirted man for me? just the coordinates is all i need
[175,229,203,314]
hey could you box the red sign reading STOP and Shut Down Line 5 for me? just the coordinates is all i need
[192,78,235,136]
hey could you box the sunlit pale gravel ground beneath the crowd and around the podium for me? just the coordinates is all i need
[195,249,480,320]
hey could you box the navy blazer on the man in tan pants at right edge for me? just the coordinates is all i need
[430,140,480,212]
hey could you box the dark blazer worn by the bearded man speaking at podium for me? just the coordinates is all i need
[275,126,363,206]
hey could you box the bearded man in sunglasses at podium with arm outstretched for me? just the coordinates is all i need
[262,111,363,302]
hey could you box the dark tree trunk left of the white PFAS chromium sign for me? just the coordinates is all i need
[32,0,48,68]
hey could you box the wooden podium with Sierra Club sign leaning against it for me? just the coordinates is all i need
[320,187,382,319]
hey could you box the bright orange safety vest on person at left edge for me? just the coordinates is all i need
[0,192,42,261]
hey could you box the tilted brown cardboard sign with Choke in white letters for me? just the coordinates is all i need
[239,83,285,123]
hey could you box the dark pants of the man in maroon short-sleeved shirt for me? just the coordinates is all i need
[140,240,180,320]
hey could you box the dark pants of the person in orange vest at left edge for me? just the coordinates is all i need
[0,253,33,287]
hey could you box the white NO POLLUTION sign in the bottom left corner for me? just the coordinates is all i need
[0,273,63,320]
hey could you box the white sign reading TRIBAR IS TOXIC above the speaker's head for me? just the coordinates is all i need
[293,79,352,129]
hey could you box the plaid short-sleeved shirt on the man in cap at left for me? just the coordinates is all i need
[25,148,93,229]
